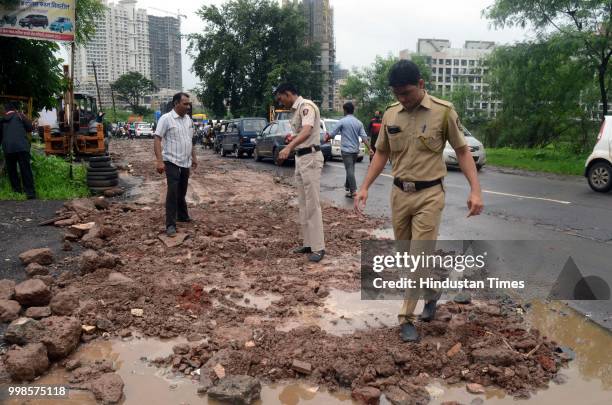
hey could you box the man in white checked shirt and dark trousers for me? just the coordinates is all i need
[155,93,198,236]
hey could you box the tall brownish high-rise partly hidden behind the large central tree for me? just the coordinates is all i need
[283,0,336,111]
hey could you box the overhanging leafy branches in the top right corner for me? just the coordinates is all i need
[484,0,612,119]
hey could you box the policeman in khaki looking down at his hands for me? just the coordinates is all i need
[275,83,325,262]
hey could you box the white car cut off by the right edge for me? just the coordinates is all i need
[584,116,612,193]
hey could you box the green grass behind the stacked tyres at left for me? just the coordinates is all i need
[0,148,89,200]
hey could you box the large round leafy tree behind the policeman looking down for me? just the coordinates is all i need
[189,0,322,117]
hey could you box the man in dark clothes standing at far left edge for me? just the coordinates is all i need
[0,101,36,200]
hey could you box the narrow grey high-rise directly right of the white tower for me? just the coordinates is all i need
[149,15,183,91]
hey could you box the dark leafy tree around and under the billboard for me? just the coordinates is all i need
[0,0,105,112]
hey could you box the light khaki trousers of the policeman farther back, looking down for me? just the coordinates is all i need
[295,152,325,252]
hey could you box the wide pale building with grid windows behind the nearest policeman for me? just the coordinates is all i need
[400,39,501,116]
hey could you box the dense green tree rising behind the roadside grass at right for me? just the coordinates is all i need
[487,34,598,150]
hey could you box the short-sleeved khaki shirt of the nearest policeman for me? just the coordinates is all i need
[376,94,467,181]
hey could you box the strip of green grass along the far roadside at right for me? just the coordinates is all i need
[487,148,589,176]
